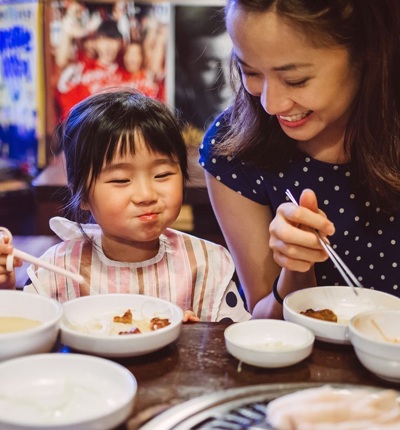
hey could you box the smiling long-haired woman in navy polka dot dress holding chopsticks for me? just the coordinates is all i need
[200,0,400,318]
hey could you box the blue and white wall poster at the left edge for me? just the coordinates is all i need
[0,0,44,176]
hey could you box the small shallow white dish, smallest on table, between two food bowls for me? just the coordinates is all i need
[224,319,314,367]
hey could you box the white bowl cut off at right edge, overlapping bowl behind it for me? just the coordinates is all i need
[349,310,400,382]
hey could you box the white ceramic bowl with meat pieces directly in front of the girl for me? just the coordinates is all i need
[60,294,183,357]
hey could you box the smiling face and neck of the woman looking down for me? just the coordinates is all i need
[227,8,360,157]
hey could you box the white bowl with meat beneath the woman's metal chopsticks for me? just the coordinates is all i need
[283,286,400,344]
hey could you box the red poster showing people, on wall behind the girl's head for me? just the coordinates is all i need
[49,0,170,120]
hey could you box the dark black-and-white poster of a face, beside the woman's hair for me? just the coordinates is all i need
[174,2,233,143]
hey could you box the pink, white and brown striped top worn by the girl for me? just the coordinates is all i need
[24,217,251,321]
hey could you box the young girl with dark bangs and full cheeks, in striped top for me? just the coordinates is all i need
[0,90,250,321]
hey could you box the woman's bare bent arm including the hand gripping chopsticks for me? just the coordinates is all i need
[205,176,334,318]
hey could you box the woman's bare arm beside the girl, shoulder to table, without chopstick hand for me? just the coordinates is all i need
[205,172,282,318]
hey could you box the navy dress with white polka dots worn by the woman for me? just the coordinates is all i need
[200,112,400,297]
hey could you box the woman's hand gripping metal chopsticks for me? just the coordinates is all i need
[269,190,335,272]
